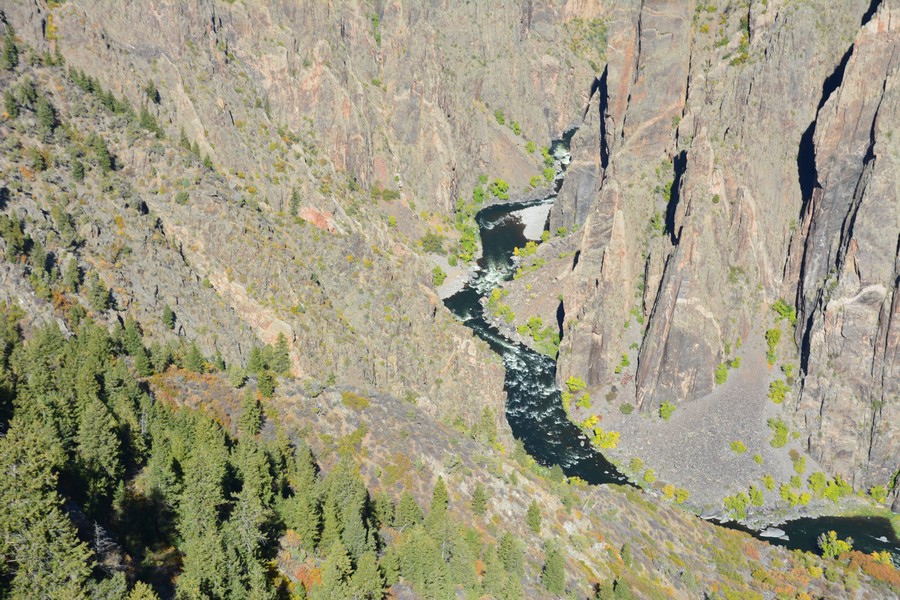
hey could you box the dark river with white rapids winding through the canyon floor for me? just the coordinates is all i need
[444,130,900,562]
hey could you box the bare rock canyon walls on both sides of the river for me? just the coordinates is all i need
[4,0,900,506]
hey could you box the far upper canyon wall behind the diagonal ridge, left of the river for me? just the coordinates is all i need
[11,0,601,212]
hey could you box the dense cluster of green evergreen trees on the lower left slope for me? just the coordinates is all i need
[0,309,563,599]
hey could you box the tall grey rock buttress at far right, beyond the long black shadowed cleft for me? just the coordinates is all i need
[786,3,900,486]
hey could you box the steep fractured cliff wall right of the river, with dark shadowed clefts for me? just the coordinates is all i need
[536,1,900,496]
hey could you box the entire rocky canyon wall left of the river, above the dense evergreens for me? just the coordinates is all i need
[3,0,616,434]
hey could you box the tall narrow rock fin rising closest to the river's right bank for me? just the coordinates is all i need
[551,2,691,394]
